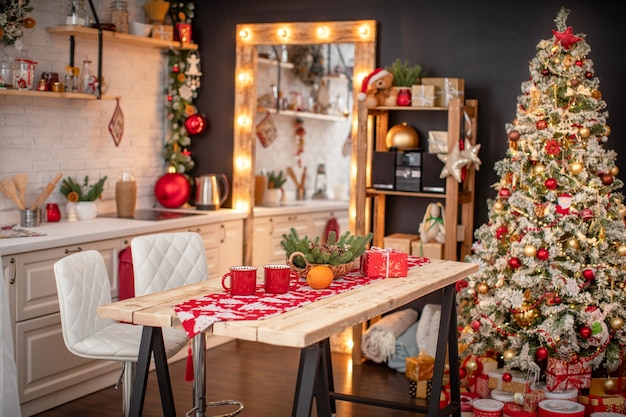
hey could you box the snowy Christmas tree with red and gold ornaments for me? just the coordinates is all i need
[457,8,626,390]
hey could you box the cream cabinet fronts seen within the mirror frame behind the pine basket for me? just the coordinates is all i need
[252,208,349,267]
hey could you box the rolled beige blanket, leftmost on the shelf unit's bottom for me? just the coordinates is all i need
[361,308,417,363]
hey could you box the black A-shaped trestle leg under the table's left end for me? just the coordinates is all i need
[130,326,176,417]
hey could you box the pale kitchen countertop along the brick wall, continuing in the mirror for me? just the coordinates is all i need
[0,200,348,255]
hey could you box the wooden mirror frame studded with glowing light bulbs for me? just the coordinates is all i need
[232,20,376,265]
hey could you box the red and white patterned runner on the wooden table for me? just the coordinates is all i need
[174,256,430,338]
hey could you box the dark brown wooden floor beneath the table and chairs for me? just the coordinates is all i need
[38,341,424,417]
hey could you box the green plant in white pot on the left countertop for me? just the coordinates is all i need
[59,175,107,220]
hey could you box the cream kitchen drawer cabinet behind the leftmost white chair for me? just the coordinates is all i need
[2,239,122,416]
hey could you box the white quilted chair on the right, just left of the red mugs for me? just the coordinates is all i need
[130,232,243,417]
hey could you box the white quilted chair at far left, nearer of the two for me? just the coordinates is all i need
[54,250,187,416]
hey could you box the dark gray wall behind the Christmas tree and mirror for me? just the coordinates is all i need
[193,0,626,233]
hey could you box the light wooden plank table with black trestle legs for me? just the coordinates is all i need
[98,260,478,417]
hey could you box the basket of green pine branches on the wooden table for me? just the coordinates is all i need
[280,227,373,278]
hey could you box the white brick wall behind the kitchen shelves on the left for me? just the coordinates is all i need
[0,0,167,214]
